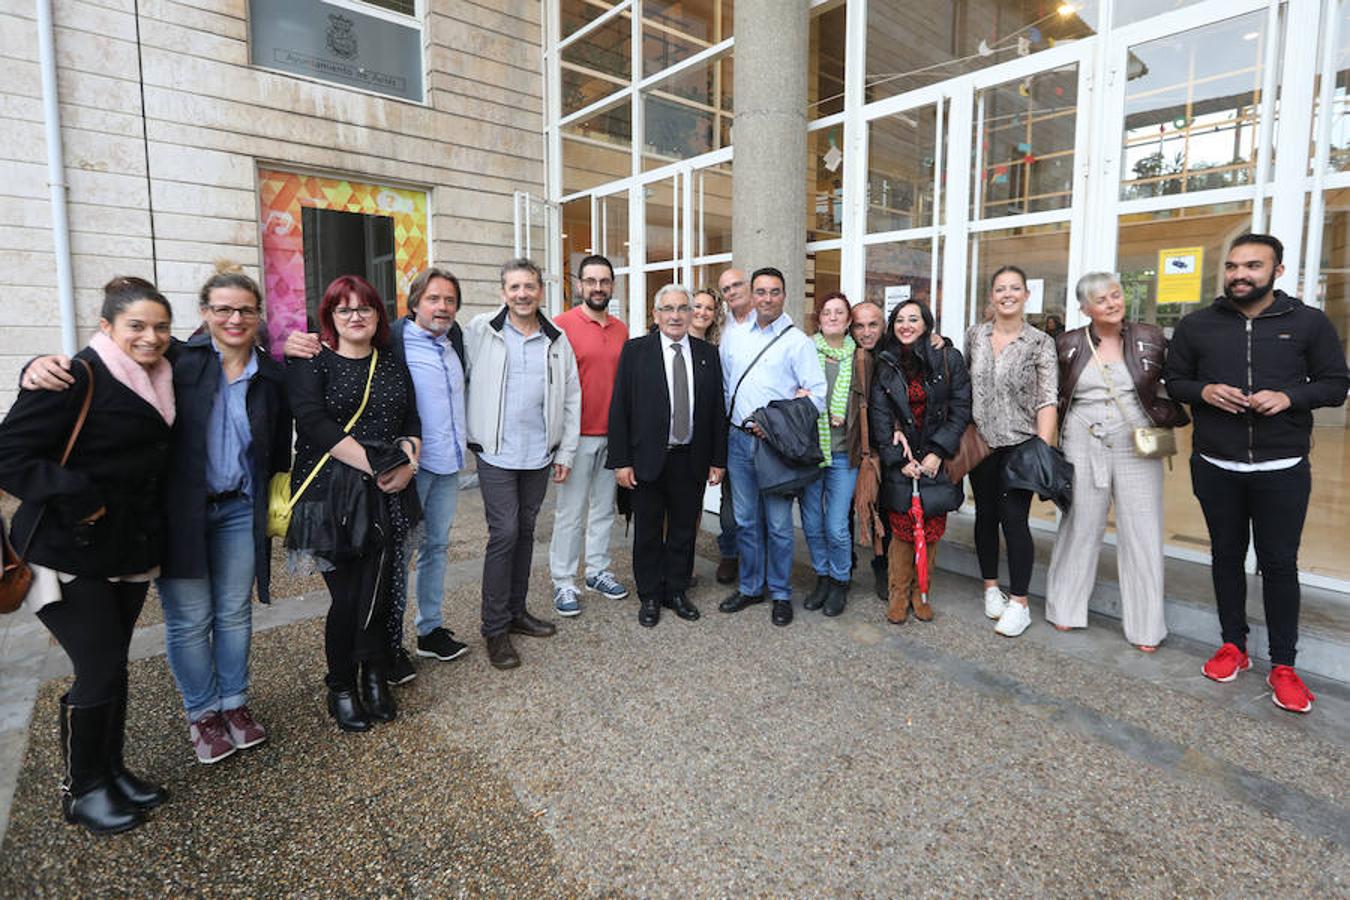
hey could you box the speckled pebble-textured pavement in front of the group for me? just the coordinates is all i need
[0,493,1350,897]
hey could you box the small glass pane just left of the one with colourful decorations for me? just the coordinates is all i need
[867,105,938,233]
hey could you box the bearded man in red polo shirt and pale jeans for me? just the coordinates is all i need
[548,256,628,615]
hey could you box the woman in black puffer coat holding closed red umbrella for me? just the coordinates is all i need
[869,301,971,625]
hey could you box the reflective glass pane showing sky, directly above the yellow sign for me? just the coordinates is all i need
[1121,12,1269,200]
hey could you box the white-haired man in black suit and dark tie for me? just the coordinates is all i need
[606,285,726,627]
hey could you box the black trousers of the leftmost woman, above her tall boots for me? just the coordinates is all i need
[38,578,150,706]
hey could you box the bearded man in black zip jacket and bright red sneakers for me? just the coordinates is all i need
[1164,235,1350,712]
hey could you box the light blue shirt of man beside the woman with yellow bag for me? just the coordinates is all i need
[404,320,468,475]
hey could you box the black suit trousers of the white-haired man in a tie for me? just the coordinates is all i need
[633,448,707,600]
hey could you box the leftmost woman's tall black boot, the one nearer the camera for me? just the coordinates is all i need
[61,698,144,834]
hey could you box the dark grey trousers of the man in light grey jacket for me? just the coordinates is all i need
[478,456,554,637]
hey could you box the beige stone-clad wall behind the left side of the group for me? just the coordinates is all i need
[0,0,544,410]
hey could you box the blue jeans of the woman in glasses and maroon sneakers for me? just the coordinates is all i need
[157,497,255,722]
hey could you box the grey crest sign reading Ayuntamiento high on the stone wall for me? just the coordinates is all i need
[248,0,423,103]
